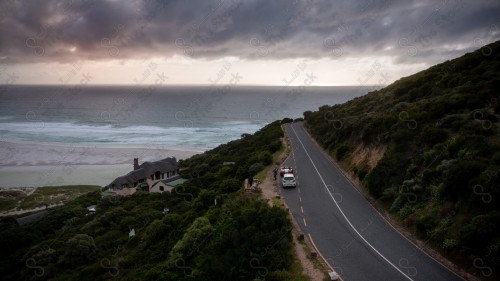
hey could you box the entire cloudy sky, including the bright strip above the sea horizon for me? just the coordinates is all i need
[0,0,500,86]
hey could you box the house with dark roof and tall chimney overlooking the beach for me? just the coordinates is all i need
[107,157,179,195]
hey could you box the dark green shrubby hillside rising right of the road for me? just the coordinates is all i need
[304,41,500,278]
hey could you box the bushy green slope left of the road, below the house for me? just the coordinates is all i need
[0,121,307,281]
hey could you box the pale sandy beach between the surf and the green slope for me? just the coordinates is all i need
[0,141,202,188]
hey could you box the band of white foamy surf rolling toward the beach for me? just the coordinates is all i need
[0,121,262,150]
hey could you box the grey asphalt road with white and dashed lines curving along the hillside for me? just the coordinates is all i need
[280,123,462,281]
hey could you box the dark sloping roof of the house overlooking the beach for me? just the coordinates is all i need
[109,157,179,188]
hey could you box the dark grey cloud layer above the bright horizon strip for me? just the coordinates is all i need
[0,0,500,63]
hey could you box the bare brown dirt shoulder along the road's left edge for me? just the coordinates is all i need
[259,131,326,281]
